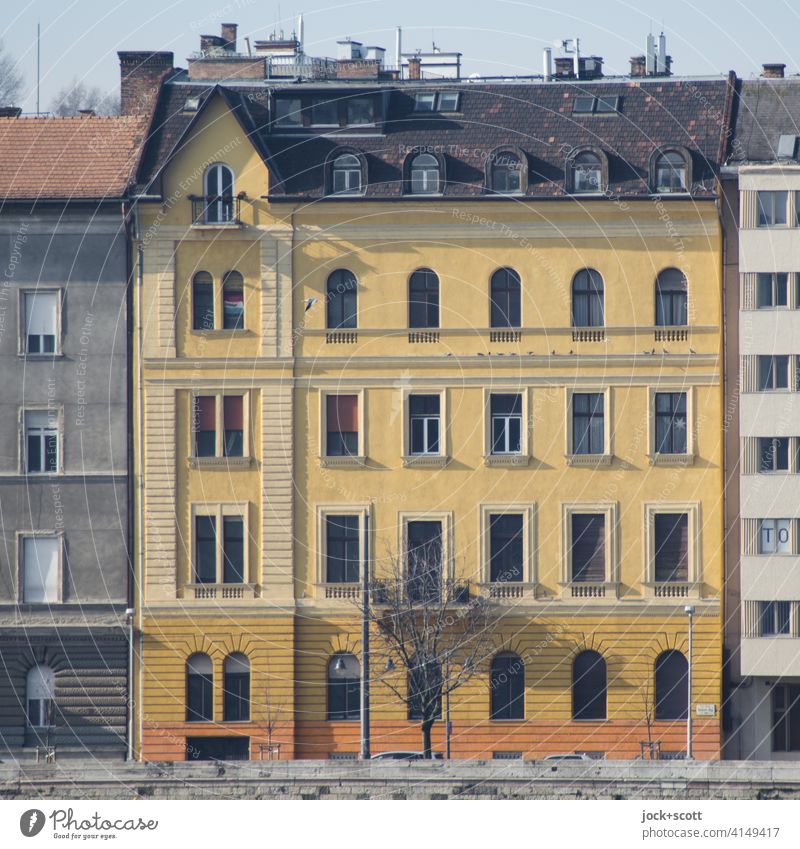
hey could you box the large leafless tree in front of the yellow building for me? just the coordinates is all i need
[358,541,500,758]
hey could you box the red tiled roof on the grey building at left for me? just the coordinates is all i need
[0,115,146,201]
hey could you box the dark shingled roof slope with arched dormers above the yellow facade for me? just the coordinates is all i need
[134,77,733,199]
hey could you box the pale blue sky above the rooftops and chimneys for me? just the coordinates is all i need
[0,0,800,110]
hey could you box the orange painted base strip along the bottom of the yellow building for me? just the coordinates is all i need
[141,719,721,761]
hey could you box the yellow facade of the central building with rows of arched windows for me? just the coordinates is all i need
[134,74,724,760]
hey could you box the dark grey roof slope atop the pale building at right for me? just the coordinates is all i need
[730,78,800,162]
